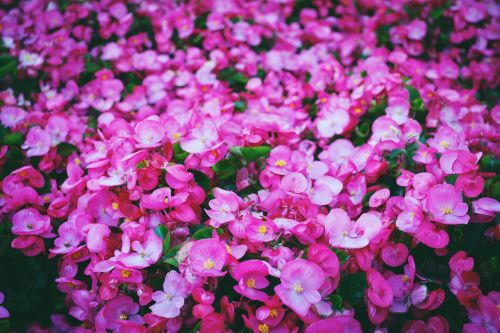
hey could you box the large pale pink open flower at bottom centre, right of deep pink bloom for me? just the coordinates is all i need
[274,259,325,316]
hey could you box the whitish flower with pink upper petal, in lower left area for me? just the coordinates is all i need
[116,229,163,268]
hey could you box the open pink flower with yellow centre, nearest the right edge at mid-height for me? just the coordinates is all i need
[426,184,470,224]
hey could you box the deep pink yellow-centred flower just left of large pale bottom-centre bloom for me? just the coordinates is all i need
[231,259,269,302]
